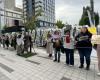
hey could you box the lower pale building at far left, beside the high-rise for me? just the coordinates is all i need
[0,0,23,29]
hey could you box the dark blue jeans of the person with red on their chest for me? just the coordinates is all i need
[65,49,74,65]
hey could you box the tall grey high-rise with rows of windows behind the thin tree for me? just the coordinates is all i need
[23,0,55,27]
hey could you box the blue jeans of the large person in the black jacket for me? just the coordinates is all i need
[78,48,92,66]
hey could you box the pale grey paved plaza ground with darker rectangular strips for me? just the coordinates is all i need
[0,48,100,80]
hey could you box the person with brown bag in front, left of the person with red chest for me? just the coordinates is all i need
[53,31,61,62]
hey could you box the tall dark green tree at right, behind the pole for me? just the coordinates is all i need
[79,6,99,26]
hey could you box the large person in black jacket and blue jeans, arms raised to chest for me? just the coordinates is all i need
[75,27,92,70]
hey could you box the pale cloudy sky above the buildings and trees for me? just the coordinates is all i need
[16,0,100,24]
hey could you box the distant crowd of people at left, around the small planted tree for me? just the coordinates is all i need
[0,32,32,55]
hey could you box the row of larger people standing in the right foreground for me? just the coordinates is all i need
[47,26,100,75]
